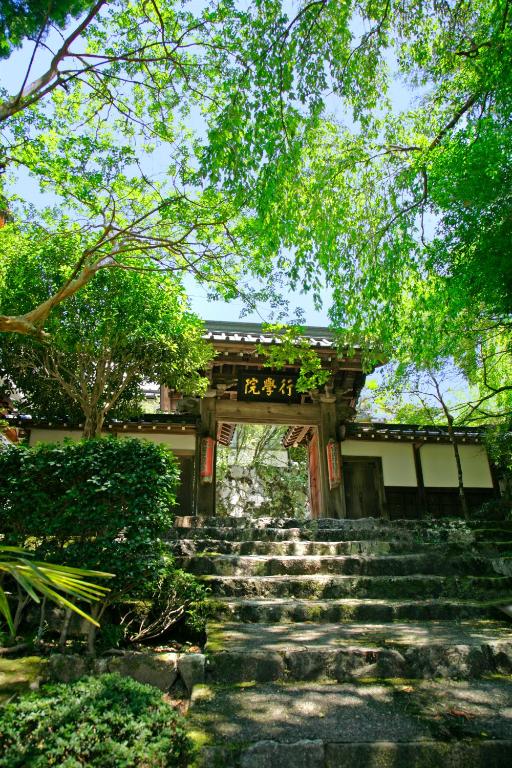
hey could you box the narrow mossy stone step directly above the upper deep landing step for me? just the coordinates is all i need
[211,598,503,624]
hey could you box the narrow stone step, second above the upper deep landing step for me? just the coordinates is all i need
[202,574,512,604]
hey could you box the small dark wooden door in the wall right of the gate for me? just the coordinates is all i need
[343,456,384,518]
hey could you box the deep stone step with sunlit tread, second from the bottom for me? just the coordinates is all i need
[206,621,512,683]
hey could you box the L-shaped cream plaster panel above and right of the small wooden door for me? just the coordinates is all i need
[341,440,416,487]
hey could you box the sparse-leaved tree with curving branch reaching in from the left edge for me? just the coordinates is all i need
[0,0,280,336]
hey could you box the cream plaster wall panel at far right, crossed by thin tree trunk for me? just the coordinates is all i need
[420,443,493,488]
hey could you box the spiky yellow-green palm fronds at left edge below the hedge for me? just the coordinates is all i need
[0,545,114,635]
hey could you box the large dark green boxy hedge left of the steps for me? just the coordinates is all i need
[0,438,179,601]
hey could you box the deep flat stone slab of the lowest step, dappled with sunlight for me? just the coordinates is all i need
[189,678,512,746]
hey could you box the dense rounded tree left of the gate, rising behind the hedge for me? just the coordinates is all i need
[0,246,211,437]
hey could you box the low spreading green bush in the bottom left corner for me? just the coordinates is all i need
[0,675,191,768]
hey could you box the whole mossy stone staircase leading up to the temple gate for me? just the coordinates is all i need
[172,518,512,768]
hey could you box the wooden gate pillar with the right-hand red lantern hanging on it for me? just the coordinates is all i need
[318,395,347,518]
